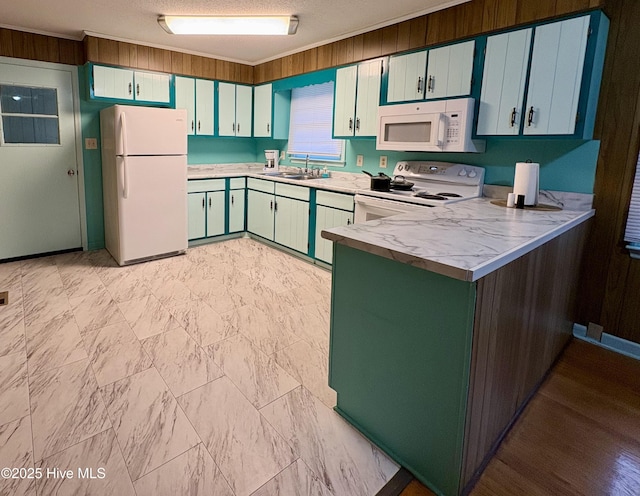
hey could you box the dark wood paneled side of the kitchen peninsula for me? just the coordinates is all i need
[462,222,590,492]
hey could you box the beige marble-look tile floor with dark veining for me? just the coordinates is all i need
[0,238,398,496]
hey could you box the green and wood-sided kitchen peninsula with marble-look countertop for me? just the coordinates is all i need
[322,199,594,495]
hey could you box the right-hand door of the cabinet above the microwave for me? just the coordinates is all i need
[425,41,475,99]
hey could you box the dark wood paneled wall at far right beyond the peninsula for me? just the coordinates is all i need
[578,0,640,343]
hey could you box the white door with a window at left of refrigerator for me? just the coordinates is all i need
[0,63,82,260]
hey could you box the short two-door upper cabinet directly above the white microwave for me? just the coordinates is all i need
[387,40,475,103]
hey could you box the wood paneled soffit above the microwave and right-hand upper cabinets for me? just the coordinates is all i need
[254,0,604,84]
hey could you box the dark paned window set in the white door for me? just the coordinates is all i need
[0,85,60,144]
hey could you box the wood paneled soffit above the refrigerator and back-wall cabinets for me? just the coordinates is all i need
[84,36,253,84]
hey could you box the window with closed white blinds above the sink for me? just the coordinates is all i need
[288,82,344,163]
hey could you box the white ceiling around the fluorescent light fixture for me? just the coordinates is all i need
[0,0,469,65]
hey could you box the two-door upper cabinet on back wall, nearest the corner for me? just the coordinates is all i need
[218,83,253,137]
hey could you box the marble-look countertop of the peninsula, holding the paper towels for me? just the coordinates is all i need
[322,198,595,281]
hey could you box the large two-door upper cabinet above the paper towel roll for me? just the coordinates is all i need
[477,12,609,139]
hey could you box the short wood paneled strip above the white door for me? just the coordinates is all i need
[0,28,84,65]
